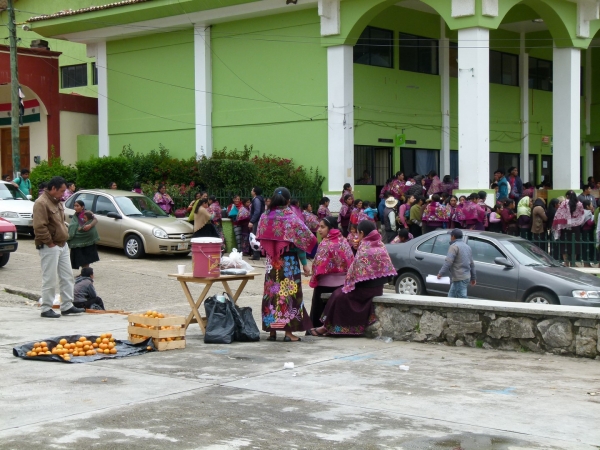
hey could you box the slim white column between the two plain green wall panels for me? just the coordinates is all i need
[194,26,213,158]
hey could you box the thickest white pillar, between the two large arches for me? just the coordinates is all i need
[458,27,490,189]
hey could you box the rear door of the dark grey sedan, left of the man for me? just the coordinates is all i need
[414,233,450,295]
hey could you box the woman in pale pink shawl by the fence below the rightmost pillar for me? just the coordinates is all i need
[552,191,585,266]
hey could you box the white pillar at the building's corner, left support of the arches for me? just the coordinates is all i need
[327,45,354,192]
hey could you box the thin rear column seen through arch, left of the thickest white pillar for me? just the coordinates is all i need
[439,17,450,178]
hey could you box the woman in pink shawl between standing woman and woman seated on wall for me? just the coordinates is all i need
[306,216,354,335]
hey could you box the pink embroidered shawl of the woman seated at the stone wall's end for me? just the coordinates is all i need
[342,230,398,294]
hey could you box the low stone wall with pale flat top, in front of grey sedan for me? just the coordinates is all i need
[367,294,600,359]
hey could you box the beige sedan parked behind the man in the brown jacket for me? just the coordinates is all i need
[65,189,193,259]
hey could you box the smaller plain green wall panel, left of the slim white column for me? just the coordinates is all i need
[106,29,195,158]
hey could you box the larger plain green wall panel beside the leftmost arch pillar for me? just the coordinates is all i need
[211,9,327,175]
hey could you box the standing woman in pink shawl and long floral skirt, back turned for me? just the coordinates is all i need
[256,187,317,342]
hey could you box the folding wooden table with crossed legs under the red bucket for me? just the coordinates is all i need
[169,272,260,333]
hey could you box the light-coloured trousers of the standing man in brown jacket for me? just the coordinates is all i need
[38,244,75,312]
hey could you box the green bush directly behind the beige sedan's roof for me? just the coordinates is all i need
[77,156,135,190]
